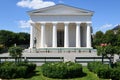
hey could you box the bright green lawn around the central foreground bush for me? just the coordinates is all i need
[14,67,108,80]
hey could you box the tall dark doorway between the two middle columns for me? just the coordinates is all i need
[57,30,64,47]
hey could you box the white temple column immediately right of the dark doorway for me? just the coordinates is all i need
[64,23,69,47]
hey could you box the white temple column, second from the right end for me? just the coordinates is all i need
[76,23,81,47]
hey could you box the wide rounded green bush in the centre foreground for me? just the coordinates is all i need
[42,62,83,79]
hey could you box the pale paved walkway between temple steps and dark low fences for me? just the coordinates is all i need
[0,53,97,61]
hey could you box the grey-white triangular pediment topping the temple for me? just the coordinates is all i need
[29,4,93,15]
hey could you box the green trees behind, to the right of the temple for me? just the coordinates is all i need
[93,29,120,48]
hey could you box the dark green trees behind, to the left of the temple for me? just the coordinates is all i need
[0,30,30,47]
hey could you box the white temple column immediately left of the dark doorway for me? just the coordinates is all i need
[52,23,57,47]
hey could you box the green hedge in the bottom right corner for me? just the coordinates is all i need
[88,62,120,80]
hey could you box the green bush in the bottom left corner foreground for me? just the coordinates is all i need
[0,62,36,79]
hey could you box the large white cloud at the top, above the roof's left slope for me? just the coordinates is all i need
[17,0,55,9]
